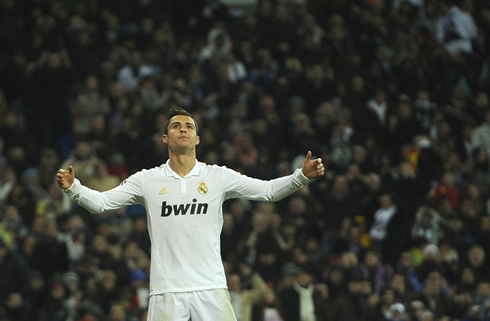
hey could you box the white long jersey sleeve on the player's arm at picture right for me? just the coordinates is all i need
[223,167,310,202]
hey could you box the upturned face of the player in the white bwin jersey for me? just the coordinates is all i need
[162,115,200,149]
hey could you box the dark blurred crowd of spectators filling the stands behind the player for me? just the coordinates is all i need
[0,0,490,321]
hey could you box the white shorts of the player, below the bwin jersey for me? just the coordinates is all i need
[147,289,236,321]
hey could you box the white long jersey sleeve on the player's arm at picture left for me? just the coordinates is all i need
[65,172,143,214]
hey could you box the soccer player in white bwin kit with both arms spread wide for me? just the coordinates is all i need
[56,107,325,321]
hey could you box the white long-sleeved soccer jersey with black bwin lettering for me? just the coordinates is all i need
[66,161,310,295]
